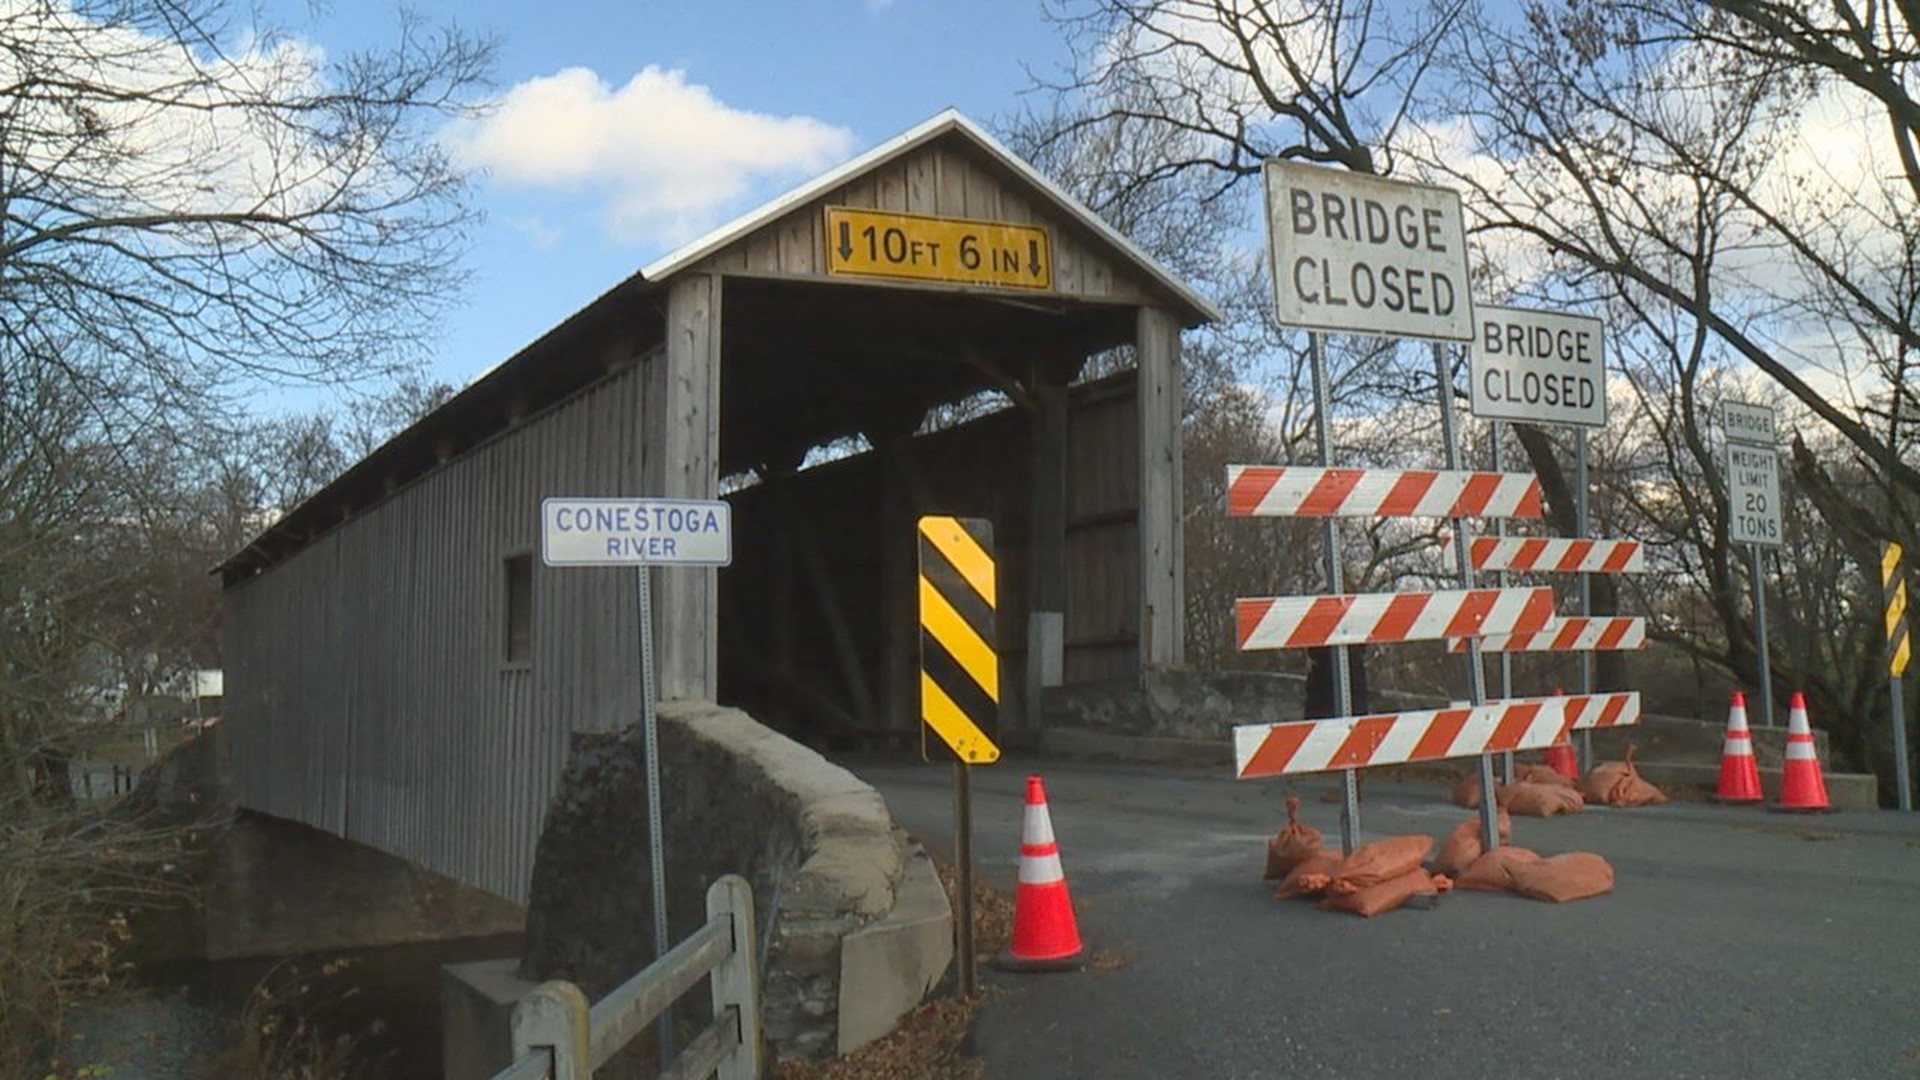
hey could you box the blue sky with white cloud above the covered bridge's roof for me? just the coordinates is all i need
[278,0,1066,395]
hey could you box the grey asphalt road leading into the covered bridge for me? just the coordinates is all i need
[851,761,1920,1080]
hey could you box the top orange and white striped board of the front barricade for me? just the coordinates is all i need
[1227,465,1542,517]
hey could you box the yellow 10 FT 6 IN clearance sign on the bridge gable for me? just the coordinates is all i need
[828,206,1054,288]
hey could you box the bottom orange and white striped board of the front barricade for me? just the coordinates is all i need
[1233,690,1640,780]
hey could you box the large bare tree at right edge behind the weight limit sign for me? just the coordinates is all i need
[1415,0,1920,765]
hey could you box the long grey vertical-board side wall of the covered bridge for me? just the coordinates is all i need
[223,361,656,903]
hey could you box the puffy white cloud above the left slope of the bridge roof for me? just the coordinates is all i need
[444,65,854,242]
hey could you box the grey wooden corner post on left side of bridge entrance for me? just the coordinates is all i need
[647,275,722,700]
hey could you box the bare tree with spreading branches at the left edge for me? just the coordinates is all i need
[0,0,490,776]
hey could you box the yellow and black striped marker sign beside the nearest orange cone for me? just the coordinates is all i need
[920,517,1000,765]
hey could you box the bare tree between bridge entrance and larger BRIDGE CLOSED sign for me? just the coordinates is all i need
[1010,0,1482,667]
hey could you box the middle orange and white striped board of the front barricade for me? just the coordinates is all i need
[1233,586,1553,651]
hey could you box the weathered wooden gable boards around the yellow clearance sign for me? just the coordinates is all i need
[699,138,1156,304]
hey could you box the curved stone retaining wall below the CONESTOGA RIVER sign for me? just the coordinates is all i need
[522,701,950,1076]
